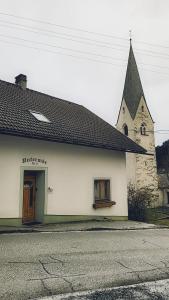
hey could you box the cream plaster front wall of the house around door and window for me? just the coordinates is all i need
[0,135,128,218]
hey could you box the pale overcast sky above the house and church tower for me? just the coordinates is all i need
[0,0,169,144]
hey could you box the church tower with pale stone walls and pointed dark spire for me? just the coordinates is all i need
[116,42,158,195]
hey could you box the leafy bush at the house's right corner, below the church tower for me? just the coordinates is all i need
[128,184,154,222]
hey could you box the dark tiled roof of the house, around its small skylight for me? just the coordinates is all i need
[0,80,146,153]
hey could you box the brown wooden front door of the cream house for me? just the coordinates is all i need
[23,176,36,223]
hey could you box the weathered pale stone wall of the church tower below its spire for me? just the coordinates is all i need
[116,97,159,205]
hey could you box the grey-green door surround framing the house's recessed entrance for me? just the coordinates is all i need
[19,166,48,223]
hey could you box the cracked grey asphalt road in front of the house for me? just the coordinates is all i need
[0,229,169,300]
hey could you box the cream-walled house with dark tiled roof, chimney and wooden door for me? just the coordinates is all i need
[0,74,146,225]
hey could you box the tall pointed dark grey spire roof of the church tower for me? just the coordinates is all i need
[123,41,145,119]
